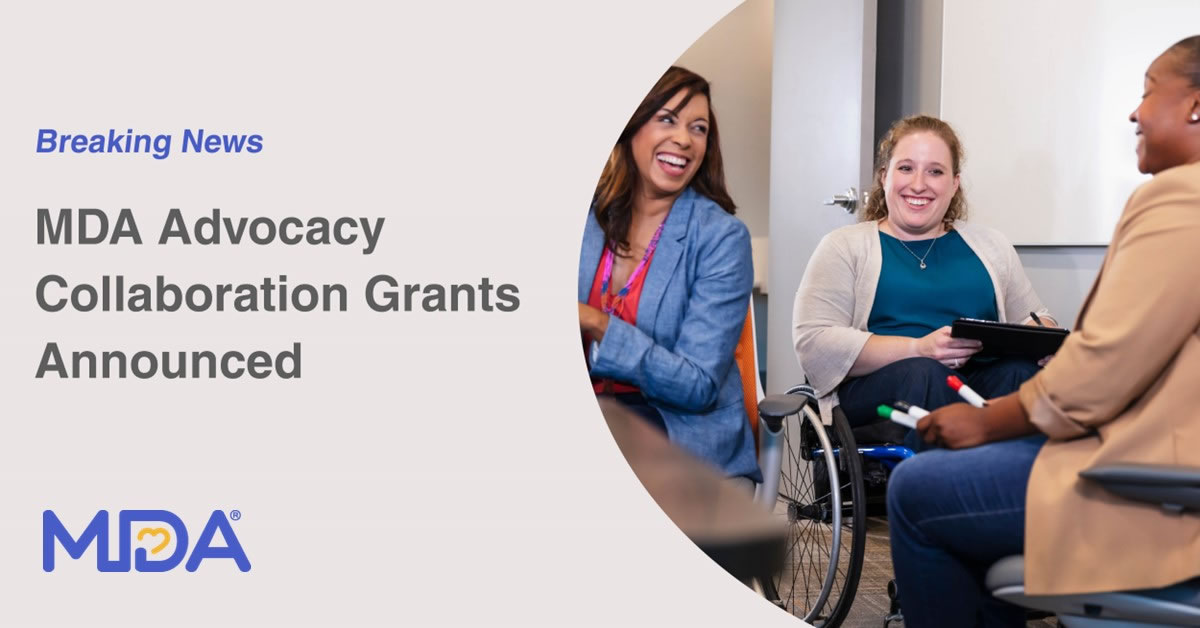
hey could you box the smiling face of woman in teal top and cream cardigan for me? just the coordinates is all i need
[883,131,959,239]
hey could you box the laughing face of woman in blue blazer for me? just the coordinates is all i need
[630,90,709,198]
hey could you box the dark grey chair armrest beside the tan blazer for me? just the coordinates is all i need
[1079,465,1200,514]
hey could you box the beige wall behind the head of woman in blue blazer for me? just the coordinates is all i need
[677,0,774,238]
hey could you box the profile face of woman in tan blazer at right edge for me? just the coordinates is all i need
[1129,50,1200,174]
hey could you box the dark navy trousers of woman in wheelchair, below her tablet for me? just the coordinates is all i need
[838,358,1038,450]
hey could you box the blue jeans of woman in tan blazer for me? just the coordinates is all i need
[888,435,1046,628]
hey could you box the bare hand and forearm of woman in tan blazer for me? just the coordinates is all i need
[917,393,1038,449]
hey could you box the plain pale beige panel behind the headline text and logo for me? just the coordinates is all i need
[0,0,796,626]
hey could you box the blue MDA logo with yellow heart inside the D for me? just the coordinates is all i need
[42,510,250,572]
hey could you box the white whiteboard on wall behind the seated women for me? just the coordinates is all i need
[941,0,1200,245]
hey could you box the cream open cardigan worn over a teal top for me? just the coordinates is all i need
[792,221,1049,424]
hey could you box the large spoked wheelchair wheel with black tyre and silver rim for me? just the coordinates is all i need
[764,387,866,627]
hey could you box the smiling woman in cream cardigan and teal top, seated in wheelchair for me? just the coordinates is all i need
[792,115,1056,445]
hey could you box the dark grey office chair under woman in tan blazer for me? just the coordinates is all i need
[986,465,1200,628]
